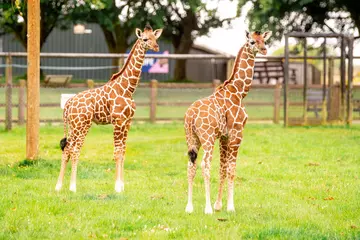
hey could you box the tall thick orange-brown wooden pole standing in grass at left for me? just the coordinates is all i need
[26,0,40,160]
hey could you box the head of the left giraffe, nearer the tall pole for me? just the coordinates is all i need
[135,25,162,52]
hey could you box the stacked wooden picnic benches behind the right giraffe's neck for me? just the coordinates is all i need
[254,61,297,84]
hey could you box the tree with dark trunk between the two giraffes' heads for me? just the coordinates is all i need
[149,0,232,81]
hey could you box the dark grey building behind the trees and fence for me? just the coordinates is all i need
[0,24,231,82]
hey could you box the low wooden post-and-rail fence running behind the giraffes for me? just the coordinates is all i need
[0,79,282,127]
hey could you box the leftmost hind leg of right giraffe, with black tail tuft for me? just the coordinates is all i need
[185,134,200,213]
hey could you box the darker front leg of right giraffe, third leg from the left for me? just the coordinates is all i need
[214,137,228,211]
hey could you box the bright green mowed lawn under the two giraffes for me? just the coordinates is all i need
[0,123,360,239]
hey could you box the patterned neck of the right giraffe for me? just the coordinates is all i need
[224,43,255,98]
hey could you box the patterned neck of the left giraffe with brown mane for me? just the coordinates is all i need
[110,40,146,95]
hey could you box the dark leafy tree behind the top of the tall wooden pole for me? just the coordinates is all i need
[0,0,69,49]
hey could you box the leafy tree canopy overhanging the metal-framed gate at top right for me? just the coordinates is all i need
[238,0,360,39]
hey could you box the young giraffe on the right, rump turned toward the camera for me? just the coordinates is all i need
[184,31,272,214]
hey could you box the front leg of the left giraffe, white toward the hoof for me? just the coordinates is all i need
[114,121,130,192]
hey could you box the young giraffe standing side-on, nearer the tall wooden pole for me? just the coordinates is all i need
[55,25,162,192]
